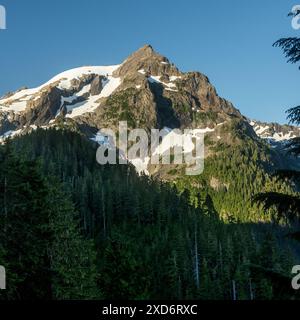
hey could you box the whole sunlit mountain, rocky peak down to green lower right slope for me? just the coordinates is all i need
[0,45,299,221]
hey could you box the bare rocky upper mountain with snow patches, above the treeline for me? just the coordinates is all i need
[0,45,299,174]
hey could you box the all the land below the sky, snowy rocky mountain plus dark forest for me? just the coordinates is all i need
[0,45,300,299]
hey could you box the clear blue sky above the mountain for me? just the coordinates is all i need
[0,0,300,123]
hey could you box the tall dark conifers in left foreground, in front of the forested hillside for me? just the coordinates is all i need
[0,143,99,300]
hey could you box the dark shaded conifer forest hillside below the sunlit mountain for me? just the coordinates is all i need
[0,129,297,300]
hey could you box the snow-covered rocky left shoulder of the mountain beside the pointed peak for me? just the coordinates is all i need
[0,66,120,128]
